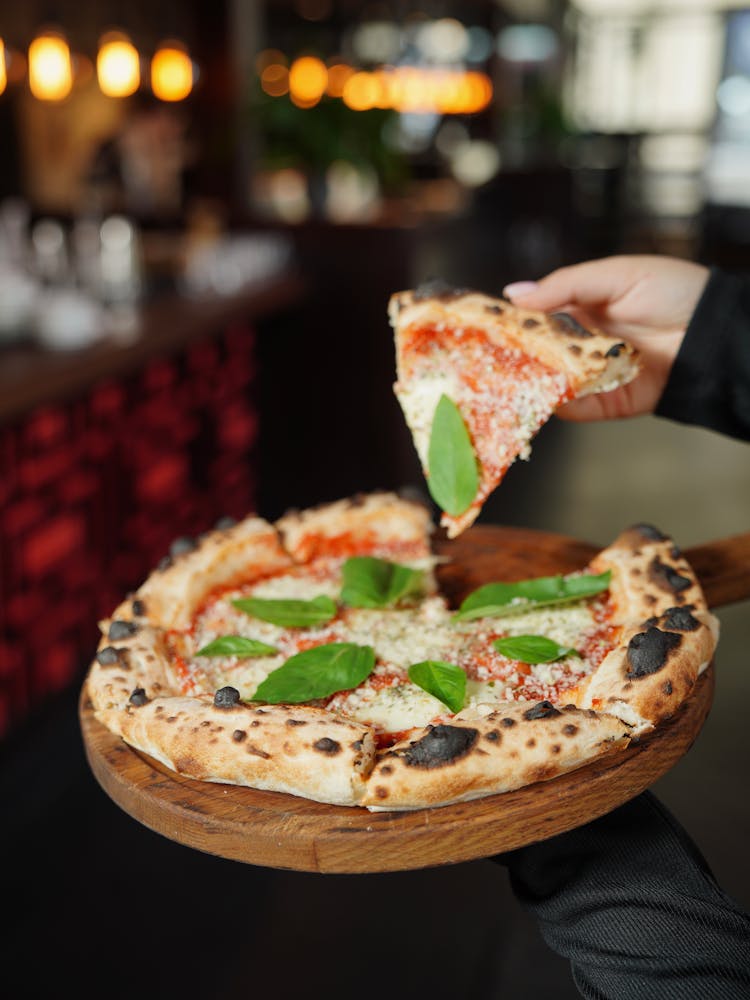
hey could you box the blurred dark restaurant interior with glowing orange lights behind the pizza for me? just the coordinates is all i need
[0,0,750,998]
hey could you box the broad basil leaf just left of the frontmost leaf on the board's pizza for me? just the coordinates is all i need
[252,642,375,705]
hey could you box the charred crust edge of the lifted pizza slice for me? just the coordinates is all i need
[388,289,640,395]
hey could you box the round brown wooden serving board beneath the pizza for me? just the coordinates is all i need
[80,526,714,873]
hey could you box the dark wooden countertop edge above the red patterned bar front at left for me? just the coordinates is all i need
[0,273,304,425]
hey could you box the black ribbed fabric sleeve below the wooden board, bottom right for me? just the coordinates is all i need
[494,792,750,1000]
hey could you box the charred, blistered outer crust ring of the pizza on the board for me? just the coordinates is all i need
[86,493,718,810]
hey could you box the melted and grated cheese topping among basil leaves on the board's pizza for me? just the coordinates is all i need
[184,561,598,732]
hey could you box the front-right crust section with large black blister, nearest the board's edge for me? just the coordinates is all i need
[360,702,630,811]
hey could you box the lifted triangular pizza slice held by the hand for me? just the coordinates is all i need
[388,282,640,538]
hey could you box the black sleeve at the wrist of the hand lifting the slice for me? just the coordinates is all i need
[654,268,750,441]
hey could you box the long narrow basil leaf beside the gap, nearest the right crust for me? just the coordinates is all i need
[454,570,612,621]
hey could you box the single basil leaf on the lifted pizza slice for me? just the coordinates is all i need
[427,395,479,517]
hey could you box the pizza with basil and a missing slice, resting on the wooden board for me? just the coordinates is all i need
[85,492,718,811]
